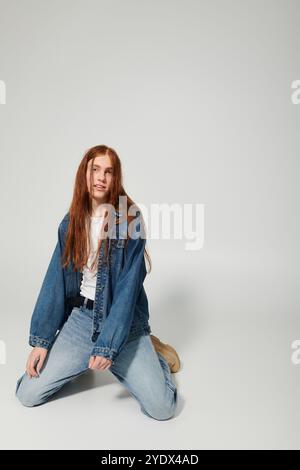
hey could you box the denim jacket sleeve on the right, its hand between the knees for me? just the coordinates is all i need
[91,237,146,363]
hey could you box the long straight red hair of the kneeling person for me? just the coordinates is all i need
[62,145,152,272]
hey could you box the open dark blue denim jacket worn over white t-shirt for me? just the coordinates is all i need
[29,212,151,363]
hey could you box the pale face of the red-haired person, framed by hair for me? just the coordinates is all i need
[86,155,113,202]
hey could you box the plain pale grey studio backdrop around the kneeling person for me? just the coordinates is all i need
[0,0,300,449]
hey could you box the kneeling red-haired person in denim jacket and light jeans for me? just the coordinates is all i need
[15,145,180,420]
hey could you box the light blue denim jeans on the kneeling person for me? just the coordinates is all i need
[15,306,177,420]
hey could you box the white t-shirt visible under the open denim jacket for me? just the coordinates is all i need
[80,216,104,300]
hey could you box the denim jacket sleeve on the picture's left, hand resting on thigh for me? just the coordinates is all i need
[29,220,66,349]
